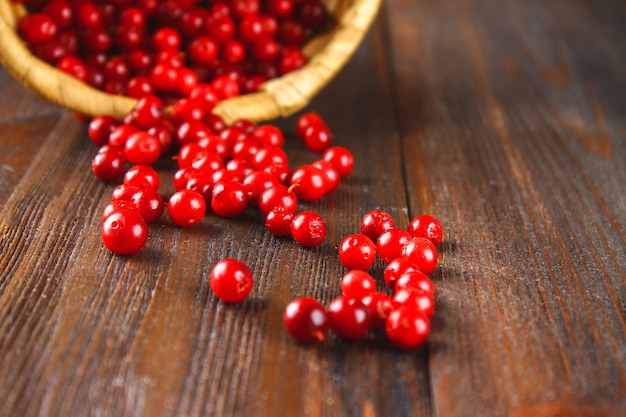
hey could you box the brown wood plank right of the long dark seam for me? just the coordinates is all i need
[387,0,626,417]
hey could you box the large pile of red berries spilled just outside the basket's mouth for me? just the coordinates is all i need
[88,96,354,254]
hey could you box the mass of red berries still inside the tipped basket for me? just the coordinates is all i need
[13,0,330,97]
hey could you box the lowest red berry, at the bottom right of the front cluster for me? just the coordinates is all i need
[385,307,430,350]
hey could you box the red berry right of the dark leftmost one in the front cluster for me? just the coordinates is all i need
[326,297,372,340]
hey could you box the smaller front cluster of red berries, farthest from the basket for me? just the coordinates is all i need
[283,210,442,349]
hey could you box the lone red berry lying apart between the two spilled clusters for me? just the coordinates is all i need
[209,259,254,303]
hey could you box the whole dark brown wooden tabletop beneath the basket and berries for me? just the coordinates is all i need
[0,0,626,417]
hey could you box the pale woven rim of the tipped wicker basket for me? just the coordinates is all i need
[0,0,381,122]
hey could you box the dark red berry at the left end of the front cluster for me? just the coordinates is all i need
[283,297,328,343]
